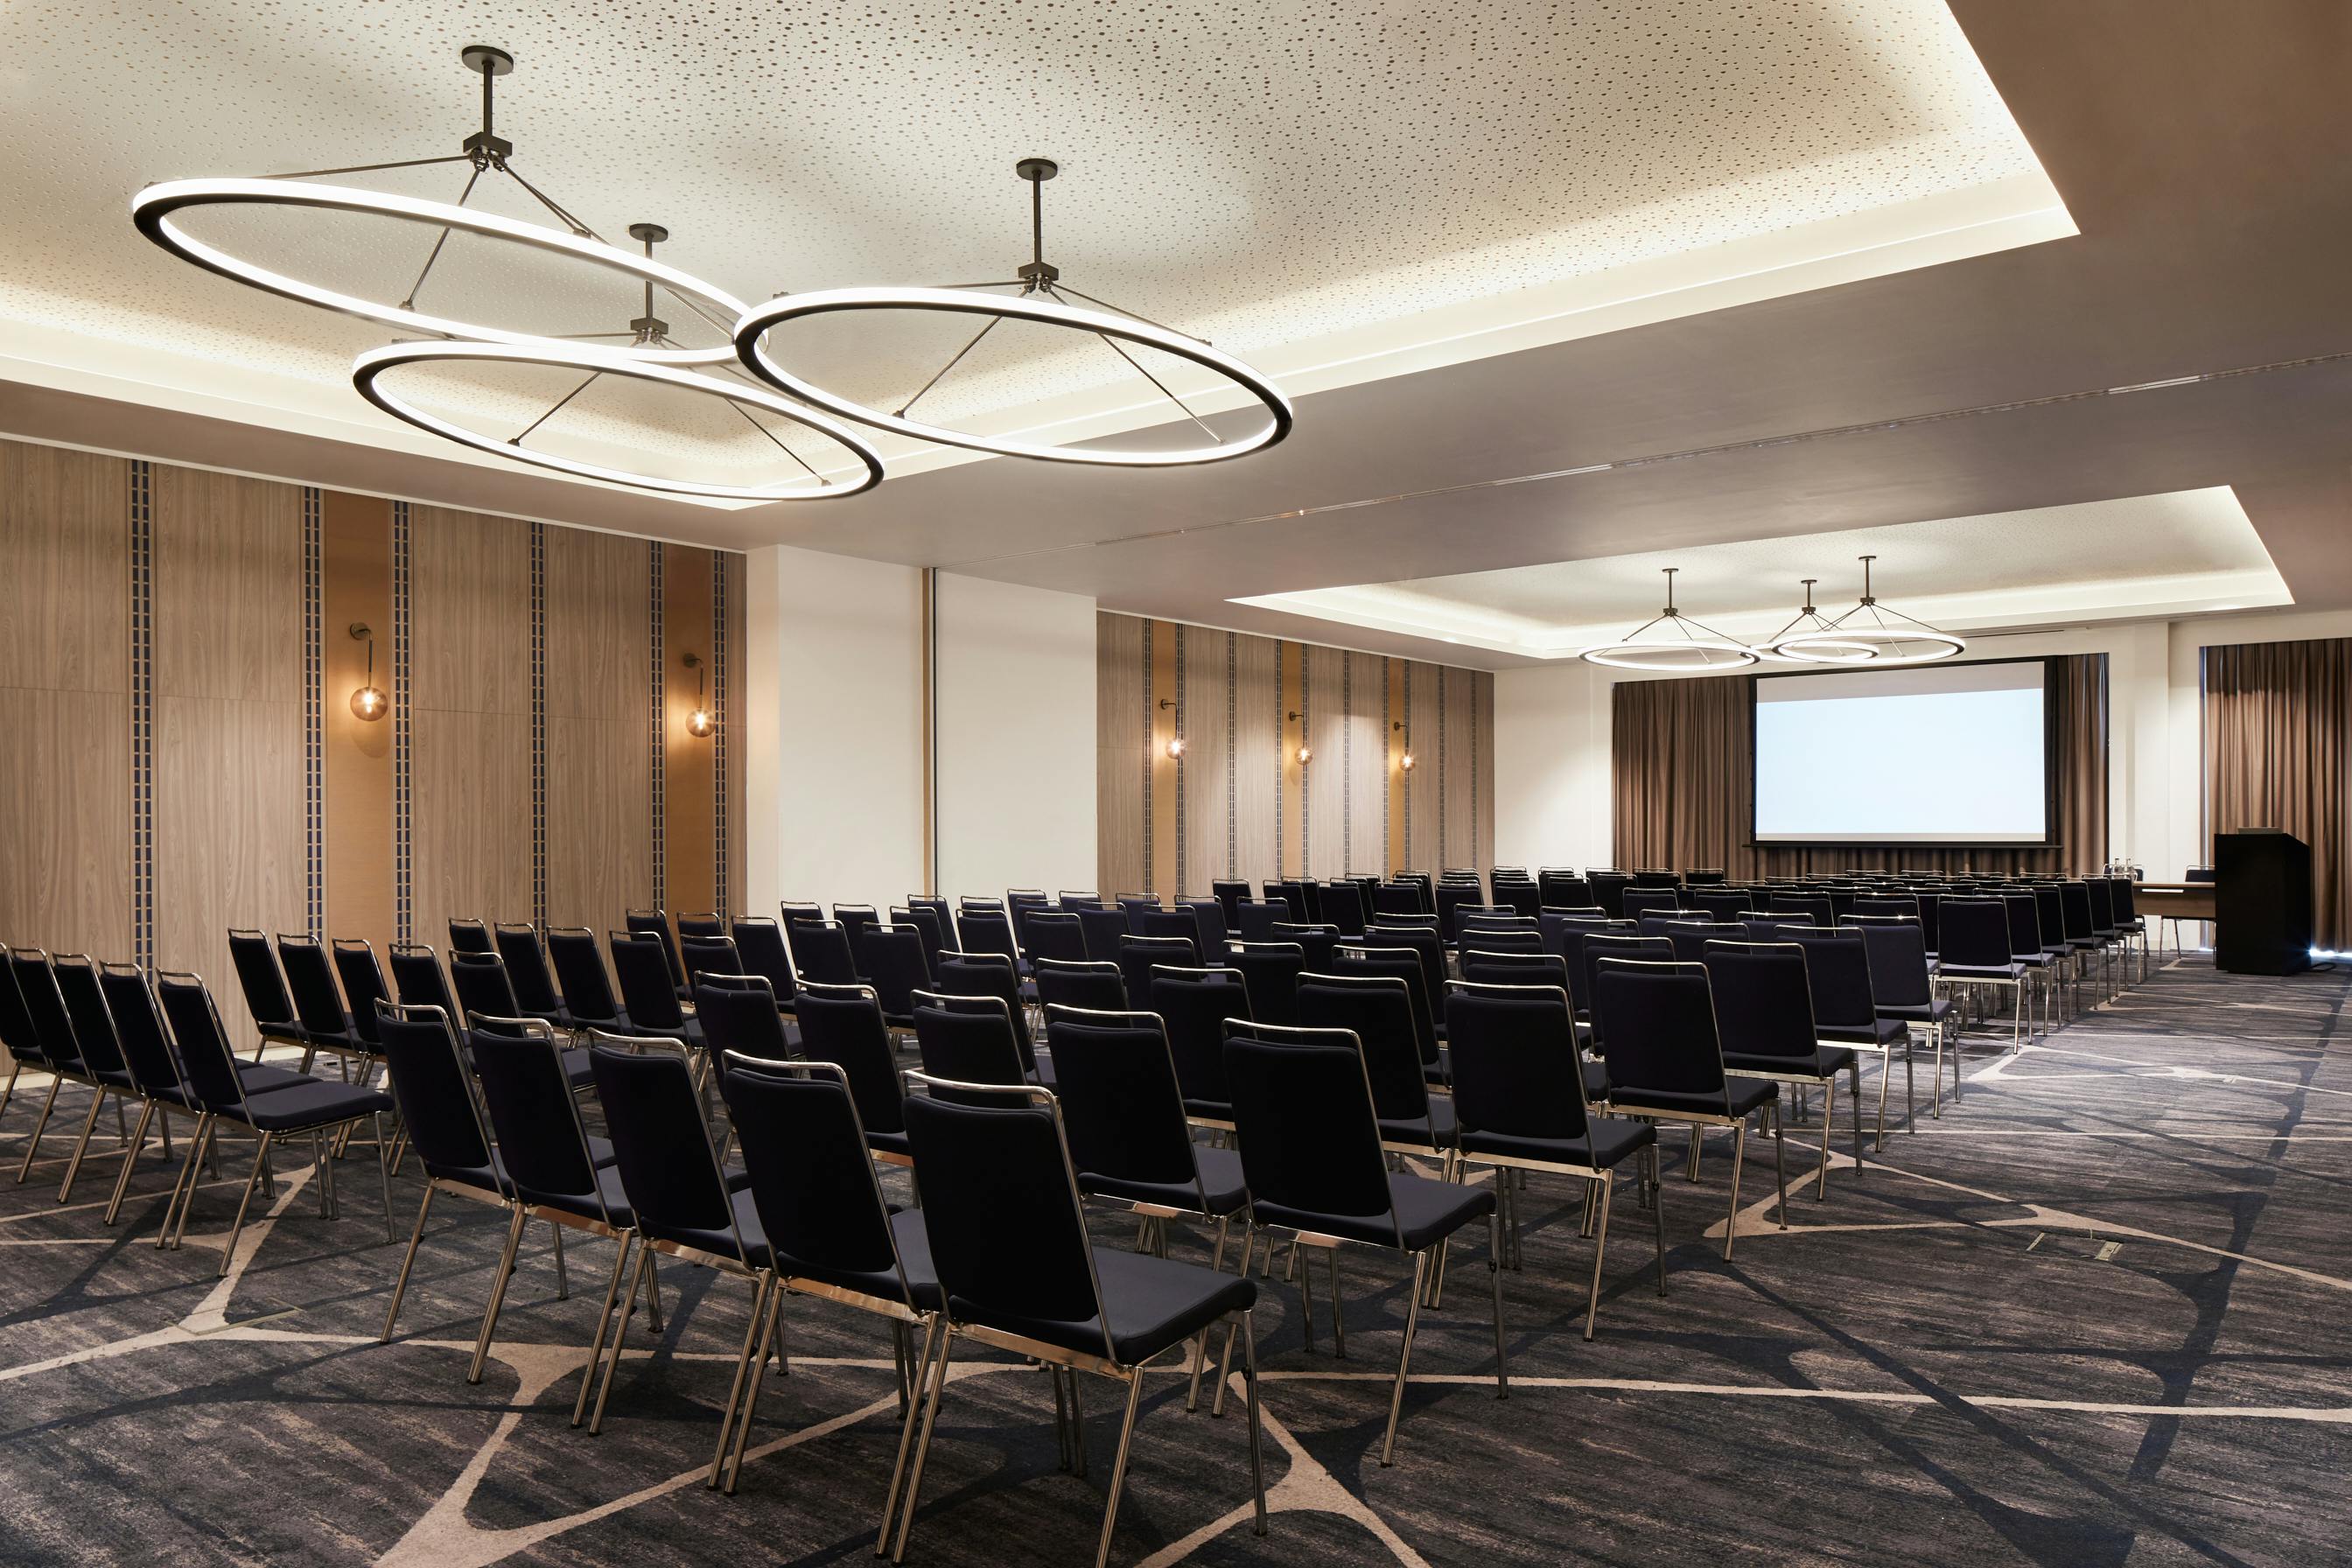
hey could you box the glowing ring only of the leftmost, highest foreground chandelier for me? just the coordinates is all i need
[132,178,743,364]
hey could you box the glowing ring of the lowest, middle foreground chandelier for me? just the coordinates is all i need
[351,343,882,500]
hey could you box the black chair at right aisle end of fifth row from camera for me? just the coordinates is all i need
[1705,941,1863,1229]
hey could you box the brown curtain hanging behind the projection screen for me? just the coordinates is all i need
[1609,654,2107,879]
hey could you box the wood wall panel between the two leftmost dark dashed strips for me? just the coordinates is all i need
[153,466,308,1046]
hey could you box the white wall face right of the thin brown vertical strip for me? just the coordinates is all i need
[934,571,1096,898]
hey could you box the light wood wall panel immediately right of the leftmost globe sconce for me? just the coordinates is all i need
[410,506,531,948]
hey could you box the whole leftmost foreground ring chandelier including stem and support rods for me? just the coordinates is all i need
[132,45,743,364]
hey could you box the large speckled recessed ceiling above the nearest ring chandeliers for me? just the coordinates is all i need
[0,0,2075,495]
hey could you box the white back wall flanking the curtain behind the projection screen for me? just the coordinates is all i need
[1494,612,2352,881]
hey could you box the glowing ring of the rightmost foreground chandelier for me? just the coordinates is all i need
[736,289,1292,468]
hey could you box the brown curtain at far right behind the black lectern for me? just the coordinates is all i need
[2204,637,2352,948]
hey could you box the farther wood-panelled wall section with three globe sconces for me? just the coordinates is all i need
[1096,612,1494,896]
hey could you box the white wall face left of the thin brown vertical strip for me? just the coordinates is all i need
[741,545,921,914]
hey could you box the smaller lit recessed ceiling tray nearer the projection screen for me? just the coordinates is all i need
[1235,486,2293,658]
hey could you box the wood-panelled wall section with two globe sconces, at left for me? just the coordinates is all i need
[0,442,743,1062]
